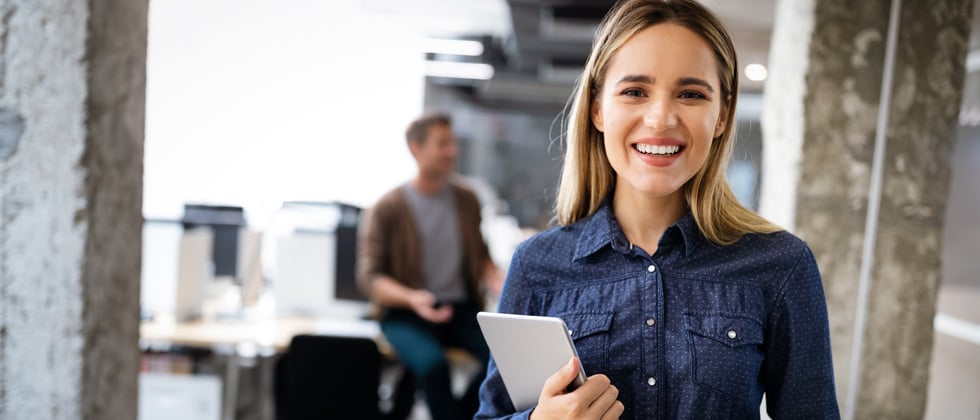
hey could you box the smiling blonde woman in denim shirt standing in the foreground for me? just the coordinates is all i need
[476,0,839,420]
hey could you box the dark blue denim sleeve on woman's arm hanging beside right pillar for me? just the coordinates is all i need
[763,246,840,419]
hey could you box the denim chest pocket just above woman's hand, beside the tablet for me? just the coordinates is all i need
[558,312,613,375]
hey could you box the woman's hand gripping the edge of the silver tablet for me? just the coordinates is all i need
[530,357,624,420]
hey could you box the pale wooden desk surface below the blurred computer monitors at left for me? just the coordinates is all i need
[140,316,387,352]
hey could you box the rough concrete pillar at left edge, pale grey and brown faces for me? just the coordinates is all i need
[0,0,147,419]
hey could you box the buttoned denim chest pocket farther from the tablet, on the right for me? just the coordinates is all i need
[686,314,765,397]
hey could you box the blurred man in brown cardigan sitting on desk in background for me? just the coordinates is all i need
[358,111,501,420]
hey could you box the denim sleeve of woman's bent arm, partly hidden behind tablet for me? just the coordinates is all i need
[473,244,534,420]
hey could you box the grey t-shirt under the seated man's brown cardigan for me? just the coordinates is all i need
[404,183,466,302]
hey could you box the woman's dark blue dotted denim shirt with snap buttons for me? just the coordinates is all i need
[475,200,840,419]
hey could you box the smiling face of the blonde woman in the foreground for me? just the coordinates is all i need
[592,23,726,197]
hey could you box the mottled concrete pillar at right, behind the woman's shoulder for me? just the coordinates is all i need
[761,0,973,419]
